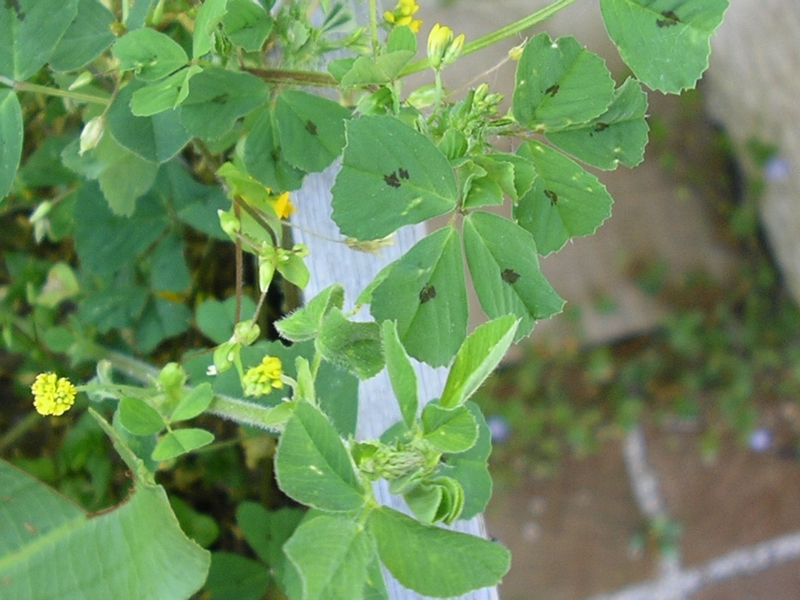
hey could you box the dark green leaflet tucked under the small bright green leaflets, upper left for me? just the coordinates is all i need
[101,79,192,163]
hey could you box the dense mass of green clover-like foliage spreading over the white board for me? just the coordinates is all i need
[0,0,728,600]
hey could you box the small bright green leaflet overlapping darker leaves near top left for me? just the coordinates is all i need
[112,27,189,81]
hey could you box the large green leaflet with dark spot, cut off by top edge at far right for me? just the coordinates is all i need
[600,0,728,94]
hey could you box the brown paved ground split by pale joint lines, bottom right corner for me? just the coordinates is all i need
[486,412,800,600]
